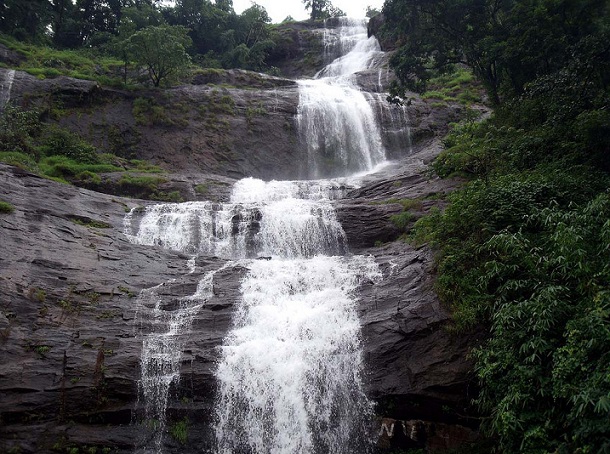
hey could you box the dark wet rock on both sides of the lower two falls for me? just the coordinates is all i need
[0,137,470,453]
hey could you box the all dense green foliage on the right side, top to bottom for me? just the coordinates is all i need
[384,0,610,453]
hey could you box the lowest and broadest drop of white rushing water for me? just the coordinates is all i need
[216,256,379,454]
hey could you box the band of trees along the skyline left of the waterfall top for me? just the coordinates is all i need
[0,0,343,86]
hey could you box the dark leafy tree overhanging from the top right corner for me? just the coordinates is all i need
[383,0,608,104]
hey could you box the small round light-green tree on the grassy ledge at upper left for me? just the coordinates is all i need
[127,25,191,87]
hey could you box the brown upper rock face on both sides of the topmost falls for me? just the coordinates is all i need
[0,61,462,184]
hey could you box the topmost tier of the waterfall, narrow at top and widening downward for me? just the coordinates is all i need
[297,19,385,178]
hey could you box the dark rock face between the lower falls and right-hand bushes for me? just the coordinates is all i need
[337,142,476,449]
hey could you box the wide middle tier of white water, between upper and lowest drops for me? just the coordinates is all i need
[125,178,346,259]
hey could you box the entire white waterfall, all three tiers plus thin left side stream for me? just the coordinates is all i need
[124,15,408,454]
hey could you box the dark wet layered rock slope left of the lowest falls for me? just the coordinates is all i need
[0,165,243,453]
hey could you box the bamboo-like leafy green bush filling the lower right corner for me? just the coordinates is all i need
[475,193,610,452]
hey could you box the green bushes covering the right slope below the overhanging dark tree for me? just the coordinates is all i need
[413,145,610,453]
